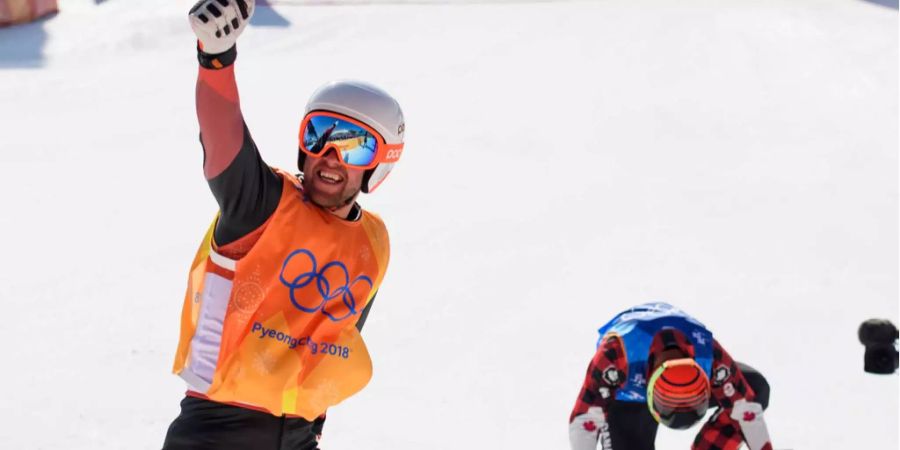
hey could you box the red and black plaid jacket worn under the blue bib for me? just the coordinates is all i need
[569,329,772,450]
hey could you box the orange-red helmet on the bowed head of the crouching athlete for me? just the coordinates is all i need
[647,358,710,430]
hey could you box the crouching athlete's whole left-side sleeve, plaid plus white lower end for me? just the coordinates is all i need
[569,337,628,450]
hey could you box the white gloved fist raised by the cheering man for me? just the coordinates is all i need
[188,0,255,54]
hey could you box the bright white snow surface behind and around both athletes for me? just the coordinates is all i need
[0,0,900,449]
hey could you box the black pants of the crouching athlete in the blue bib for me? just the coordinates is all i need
[606,362,769,450]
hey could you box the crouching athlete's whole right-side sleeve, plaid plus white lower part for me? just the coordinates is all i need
[691,341,772,450]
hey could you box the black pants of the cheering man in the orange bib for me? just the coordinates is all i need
[163,397,324,450]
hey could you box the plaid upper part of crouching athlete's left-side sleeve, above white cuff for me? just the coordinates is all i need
[569,337,628,424]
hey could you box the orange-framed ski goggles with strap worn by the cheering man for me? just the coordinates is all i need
[300,111,403,169]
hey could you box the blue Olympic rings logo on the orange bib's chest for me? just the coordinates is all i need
[278,249,375,322]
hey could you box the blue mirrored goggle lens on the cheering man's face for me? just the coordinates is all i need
[303,115,378,166]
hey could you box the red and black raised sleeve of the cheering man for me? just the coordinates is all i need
[196,47,282,245]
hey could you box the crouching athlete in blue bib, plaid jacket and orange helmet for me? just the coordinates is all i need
[569,303,772,450]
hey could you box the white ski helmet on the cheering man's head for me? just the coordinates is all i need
[297,80,405,193]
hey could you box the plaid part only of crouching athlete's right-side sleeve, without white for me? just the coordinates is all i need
[691,341,754,450]
